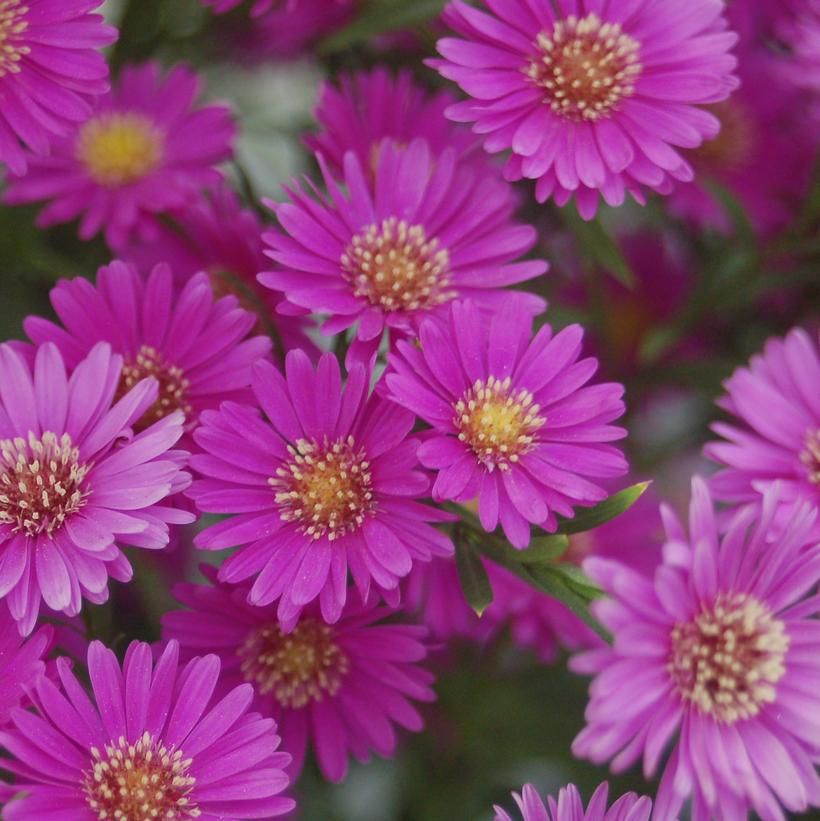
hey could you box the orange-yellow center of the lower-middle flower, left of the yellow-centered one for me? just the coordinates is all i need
[268,436,374,541]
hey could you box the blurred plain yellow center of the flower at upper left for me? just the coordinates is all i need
[77,113,164,188]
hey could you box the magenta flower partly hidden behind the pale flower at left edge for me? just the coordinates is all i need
[24,262,270,446]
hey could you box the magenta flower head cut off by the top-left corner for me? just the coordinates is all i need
[0,0,117,174]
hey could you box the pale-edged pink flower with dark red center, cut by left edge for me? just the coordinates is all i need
[0,343,193,635]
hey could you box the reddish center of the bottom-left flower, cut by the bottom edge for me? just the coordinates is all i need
[82,732,202,821]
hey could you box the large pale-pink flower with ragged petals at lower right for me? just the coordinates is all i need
[573,477,820,821]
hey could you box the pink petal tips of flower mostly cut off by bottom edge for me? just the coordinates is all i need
[494,781,652,821]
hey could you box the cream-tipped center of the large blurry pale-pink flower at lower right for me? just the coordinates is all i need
[668,594,789,724]
